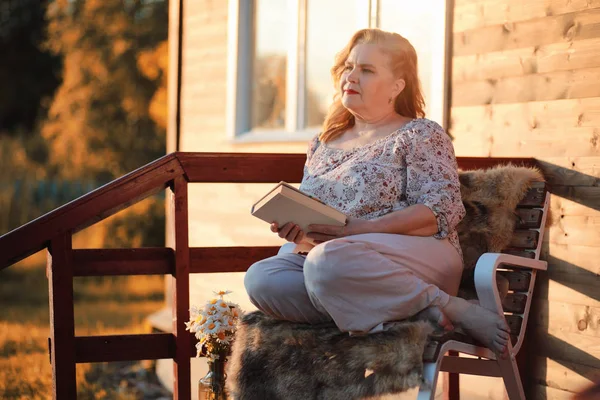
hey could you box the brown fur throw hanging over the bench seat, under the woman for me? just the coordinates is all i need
[227,312,432,400]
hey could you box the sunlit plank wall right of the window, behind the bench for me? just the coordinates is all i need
[449,0,600,399]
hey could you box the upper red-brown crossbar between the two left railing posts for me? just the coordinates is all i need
[73,247,175,276]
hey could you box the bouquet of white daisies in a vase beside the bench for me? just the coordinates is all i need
[185,290,241,400]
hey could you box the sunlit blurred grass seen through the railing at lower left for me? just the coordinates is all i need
[0,255,164,400]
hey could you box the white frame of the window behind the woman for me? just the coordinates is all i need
[226,0,448,143]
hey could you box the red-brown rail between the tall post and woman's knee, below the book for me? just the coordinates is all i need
[190,246,279,273]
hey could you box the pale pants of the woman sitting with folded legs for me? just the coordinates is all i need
[244,233,463,333]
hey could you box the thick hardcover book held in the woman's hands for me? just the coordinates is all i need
[251,181,346,250]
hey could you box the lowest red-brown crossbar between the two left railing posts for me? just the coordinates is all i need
[75,333,175,363]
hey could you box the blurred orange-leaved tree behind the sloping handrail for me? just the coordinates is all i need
[42,0,168,181]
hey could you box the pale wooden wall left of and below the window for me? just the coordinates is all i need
[179,0,306,308]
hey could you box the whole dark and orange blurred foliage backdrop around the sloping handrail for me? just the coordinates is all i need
[0,0,168,247]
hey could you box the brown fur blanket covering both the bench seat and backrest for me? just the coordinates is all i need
[227,166,542,400]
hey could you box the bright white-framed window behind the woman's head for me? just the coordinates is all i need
[227,0,445,141]
